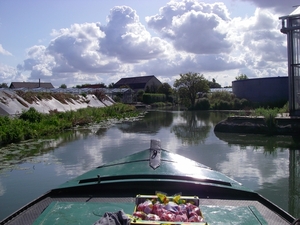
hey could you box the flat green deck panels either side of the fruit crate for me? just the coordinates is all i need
[34,202,267,225]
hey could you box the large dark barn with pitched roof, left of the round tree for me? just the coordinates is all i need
[114,75,162,92]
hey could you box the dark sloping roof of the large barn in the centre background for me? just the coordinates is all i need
[114,75,157,89]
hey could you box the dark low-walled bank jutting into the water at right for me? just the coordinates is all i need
[214,114,300,135]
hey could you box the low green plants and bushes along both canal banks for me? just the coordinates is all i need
[0,91,288,147]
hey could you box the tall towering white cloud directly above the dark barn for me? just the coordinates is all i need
[100,6,167,63]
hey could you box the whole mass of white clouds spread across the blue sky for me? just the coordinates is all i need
[12,0,287,86]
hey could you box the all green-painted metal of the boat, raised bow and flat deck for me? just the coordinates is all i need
[11,146,292,225]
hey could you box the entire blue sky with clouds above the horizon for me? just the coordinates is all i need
[0,0,299,88]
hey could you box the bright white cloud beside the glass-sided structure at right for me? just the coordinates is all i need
[229,9,287,77]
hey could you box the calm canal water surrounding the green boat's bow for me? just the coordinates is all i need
[0,110,300,220]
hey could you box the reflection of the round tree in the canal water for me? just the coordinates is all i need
[171,111,211,145]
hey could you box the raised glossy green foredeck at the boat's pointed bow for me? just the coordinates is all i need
[59,149,252,192]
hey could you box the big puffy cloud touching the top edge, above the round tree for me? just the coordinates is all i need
[146,0,231,54]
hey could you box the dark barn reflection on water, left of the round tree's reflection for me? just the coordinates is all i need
[117,111,173,133]
